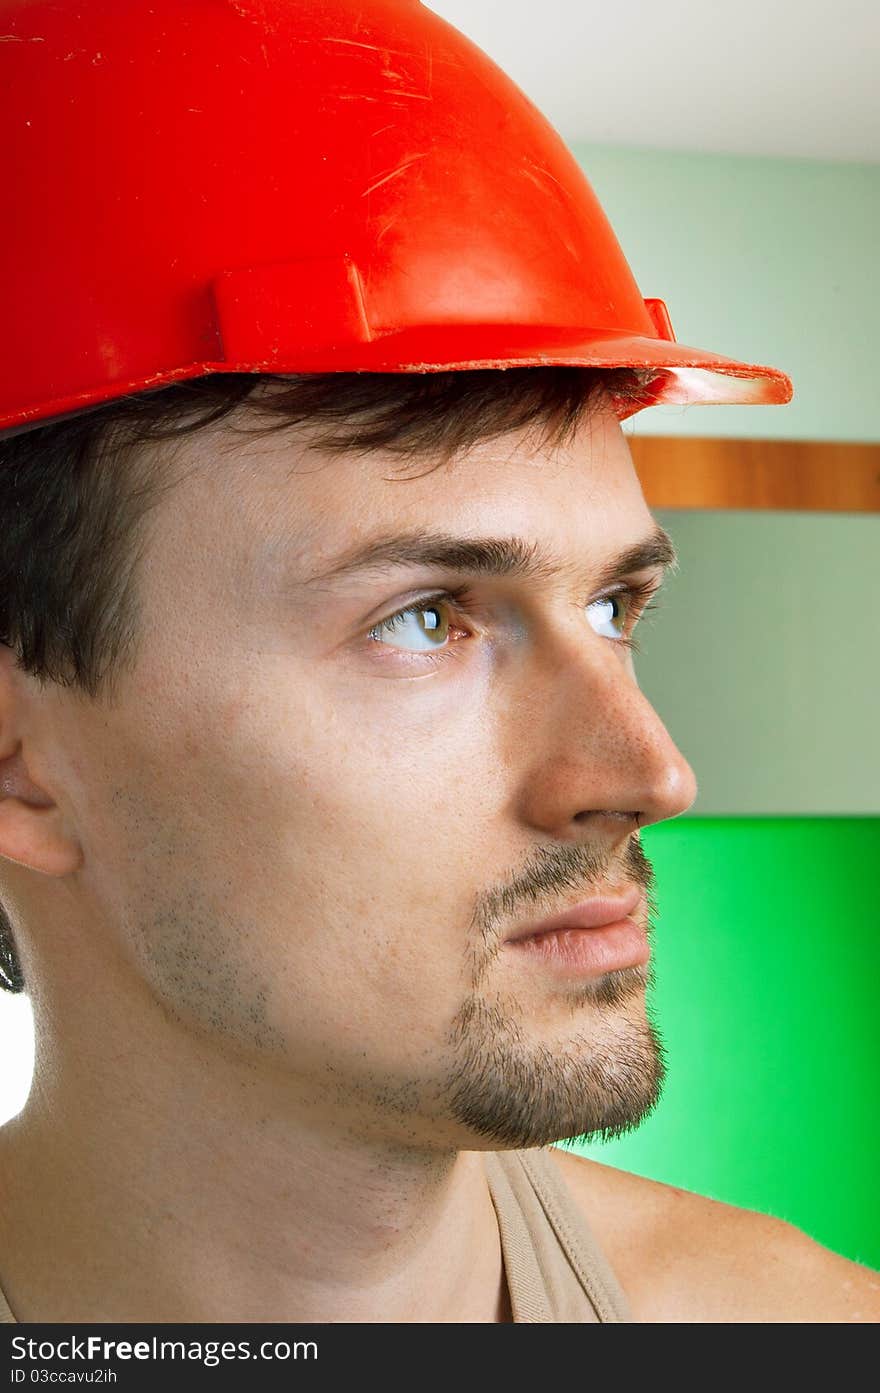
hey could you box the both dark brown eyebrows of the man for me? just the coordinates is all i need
[304,524,678,588]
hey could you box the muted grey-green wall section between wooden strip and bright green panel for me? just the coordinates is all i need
[635,512,880,816]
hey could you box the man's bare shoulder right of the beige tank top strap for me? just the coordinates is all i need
[550,1148,880,1323]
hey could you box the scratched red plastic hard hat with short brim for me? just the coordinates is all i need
[0,0,792,429]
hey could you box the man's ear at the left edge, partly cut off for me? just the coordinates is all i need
[0,644,82,875]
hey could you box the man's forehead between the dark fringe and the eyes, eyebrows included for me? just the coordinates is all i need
[190,406,660,593]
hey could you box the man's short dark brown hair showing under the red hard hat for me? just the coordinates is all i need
[0,366,653,992]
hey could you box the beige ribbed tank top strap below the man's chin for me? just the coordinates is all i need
[0,1149,635,1325]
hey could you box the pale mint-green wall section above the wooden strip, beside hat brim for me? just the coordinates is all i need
[572,143,880,440]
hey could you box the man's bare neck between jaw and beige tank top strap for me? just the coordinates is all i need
[0,1008,511,1322]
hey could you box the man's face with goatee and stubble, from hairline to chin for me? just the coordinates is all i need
[48,390,695,1149]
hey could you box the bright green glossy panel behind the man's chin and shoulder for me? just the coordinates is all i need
[556,818,880,1269]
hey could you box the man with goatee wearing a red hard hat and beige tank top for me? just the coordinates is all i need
[0,0,880,1322]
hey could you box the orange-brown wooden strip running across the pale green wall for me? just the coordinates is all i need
[627,435,880,513]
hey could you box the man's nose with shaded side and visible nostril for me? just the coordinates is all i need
[511,635,696,840]
